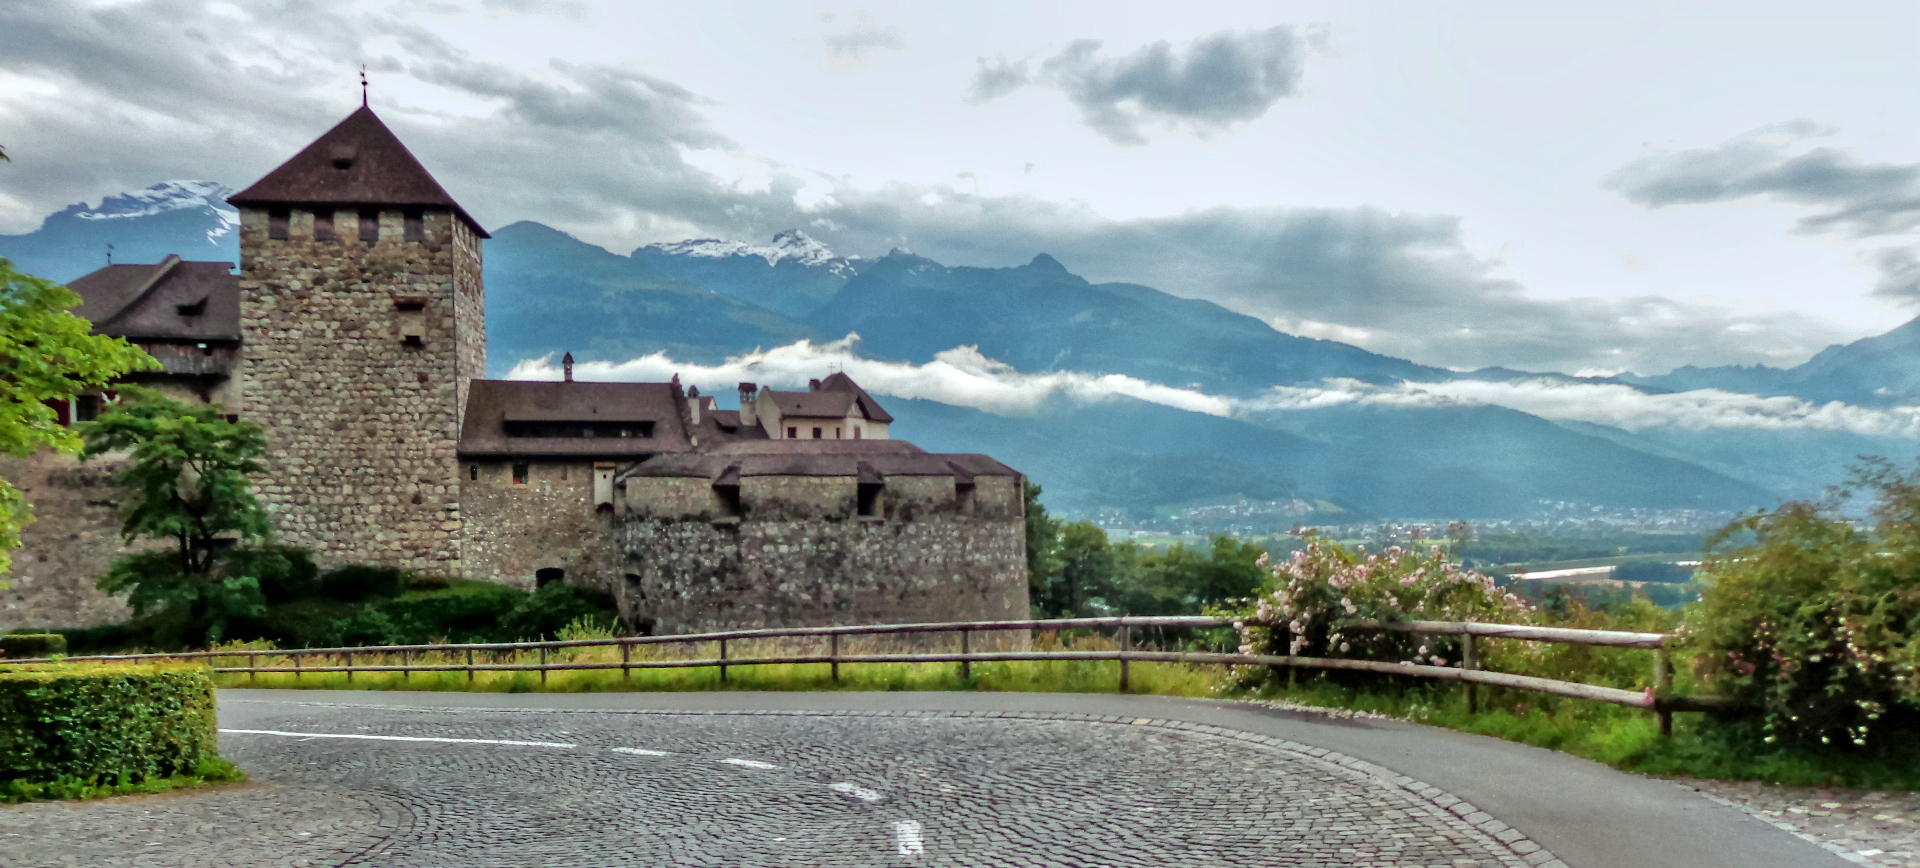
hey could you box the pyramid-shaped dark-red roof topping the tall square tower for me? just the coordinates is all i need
[227,106,488,238]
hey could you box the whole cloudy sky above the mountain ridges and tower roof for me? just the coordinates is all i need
[0,0,1920,373]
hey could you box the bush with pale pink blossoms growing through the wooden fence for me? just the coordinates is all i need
[1221,532,1532,666]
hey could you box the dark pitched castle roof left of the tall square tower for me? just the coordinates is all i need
[67,255,240,342]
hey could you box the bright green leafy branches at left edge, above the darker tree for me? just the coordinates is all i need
[0,259,157,574]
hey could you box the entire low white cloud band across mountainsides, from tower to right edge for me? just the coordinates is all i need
[507,334,1920,440]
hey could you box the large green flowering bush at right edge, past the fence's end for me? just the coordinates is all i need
[1688,461,1920,747]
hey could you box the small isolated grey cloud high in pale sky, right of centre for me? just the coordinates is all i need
[968,25,1325,144]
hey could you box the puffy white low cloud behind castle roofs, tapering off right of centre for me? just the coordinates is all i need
[507,334,1233,417]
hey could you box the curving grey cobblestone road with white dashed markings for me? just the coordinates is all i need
[0,703,1563,868]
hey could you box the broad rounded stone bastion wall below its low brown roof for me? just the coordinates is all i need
[616,476,1029,634]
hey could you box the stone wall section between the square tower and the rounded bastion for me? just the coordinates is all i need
[461,459,620,593]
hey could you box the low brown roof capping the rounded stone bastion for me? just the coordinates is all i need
[622,440,1018,484]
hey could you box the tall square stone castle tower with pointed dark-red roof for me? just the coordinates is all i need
[228,106,488,574]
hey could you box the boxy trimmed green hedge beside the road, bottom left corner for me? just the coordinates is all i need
[0,664,219,784]
